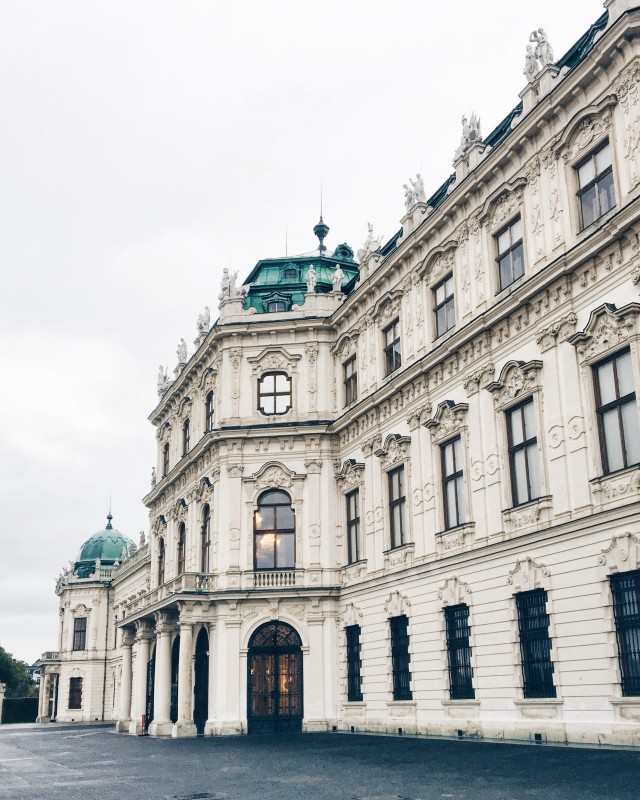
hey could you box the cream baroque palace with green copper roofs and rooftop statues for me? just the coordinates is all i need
[39,0,640,745]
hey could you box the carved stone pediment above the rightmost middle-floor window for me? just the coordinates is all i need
[568,303,640,362]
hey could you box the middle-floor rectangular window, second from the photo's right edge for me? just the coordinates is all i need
[507,397,540,506]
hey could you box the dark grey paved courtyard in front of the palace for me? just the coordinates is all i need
[0,725,640,800]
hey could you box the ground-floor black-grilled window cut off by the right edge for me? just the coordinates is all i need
[609,570,640,697]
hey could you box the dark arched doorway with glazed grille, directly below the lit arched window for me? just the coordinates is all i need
[247,622,302,733]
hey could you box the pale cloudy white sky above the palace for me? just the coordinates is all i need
[0,0,602,662]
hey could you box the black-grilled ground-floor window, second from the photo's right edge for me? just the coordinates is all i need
[516,589,556,697]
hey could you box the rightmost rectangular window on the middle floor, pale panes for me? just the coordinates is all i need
[593,350,640,474]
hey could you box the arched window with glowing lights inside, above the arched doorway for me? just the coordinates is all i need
[253,490,296,569]
